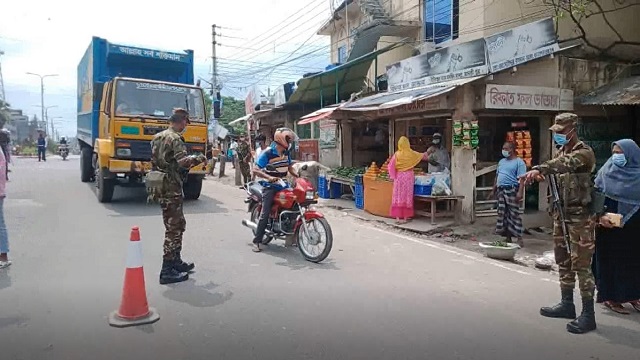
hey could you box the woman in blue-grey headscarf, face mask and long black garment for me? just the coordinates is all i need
[592,139,640,314]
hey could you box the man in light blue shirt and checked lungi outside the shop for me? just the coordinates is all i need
[491,142,527,246]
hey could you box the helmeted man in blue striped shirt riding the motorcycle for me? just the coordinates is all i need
[252,128,298,252]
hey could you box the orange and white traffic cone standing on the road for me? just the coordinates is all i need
[109,226,160,328]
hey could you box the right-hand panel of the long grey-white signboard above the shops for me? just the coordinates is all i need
[485,18,560,73]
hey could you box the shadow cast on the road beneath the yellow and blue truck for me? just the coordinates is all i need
[89,184,228,217]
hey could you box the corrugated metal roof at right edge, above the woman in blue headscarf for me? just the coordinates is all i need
[576,76,640,105]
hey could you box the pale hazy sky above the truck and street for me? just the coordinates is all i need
[0,0,332,137]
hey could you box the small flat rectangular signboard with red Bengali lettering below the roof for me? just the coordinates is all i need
[485,85,573,111]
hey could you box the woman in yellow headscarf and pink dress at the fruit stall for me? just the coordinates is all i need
[388,136,428,224]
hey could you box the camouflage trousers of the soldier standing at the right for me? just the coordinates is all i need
[553,219,596,300]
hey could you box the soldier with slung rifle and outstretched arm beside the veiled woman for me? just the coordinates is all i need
[523,113,596,334]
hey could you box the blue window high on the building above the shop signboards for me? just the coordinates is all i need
[424,0,460,44]
